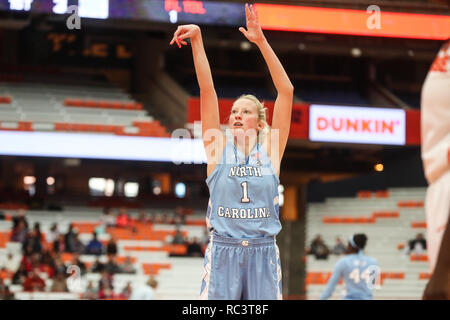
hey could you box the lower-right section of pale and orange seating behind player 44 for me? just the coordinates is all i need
[306,188,429,299]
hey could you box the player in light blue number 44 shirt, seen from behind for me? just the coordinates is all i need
[319,234,380,300]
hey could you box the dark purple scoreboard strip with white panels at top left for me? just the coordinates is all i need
[0,0,245,26]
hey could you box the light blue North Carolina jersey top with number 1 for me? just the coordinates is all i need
[206,141,281,239]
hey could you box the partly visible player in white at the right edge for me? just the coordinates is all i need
[421,39,450,299]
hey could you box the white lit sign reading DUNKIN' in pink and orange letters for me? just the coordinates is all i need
[309,104,406,145]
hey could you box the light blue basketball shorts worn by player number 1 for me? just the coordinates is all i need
[200,233,282,300]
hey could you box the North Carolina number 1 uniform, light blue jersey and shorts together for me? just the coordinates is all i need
[200,141,282,300]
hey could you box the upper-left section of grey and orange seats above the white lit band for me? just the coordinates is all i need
[0,76,170,137]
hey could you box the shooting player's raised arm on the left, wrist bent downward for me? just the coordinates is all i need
[170,24,220,171]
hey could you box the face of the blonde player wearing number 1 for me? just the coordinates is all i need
[229,99,261,135]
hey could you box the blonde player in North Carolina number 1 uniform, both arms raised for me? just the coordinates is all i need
[171,4,294,300]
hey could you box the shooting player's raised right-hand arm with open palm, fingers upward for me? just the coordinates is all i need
[239,4,294,165]
